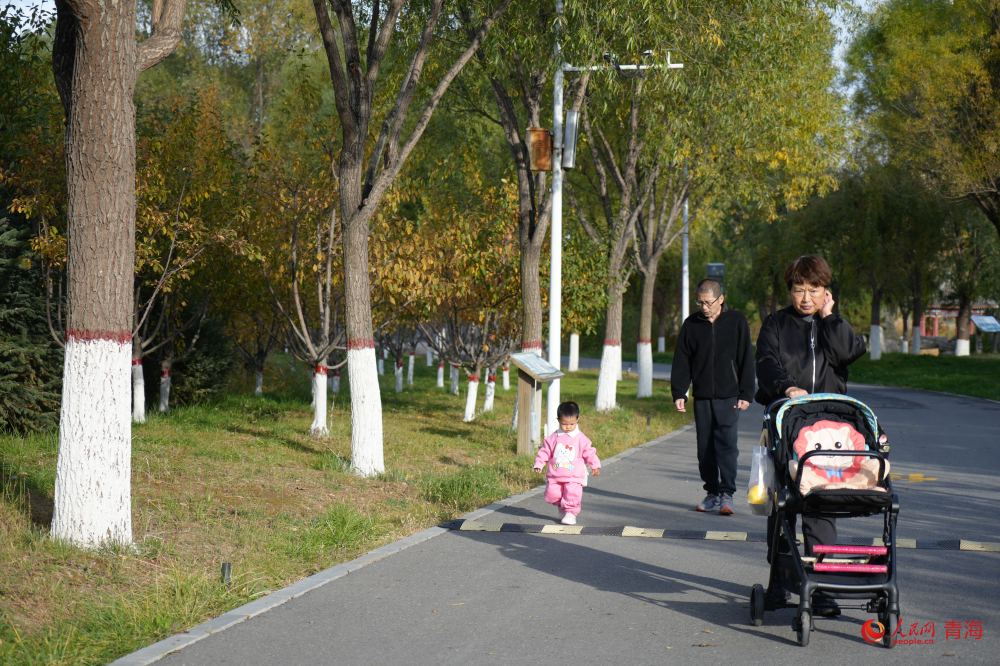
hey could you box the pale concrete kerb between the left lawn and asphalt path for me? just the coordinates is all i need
[109,423,694,666]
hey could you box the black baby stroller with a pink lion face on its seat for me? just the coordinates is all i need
[750,393,899,648]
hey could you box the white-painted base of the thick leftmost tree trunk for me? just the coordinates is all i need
[52,335,132,546]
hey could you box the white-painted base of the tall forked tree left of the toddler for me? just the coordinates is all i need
[347,347,385,476]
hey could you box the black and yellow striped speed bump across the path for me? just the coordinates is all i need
[441,519,1000,553]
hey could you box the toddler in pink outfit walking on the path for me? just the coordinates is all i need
[535,402,601,525]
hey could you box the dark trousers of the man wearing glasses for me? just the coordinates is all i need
[694,396,740,495]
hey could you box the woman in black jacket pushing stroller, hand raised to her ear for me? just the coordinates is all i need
[754,255,865,614]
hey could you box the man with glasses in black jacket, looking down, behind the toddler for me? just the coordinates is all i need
[670,280,753,515]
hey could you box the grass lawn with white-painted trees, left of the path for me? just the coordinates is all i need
[0,356,689,665]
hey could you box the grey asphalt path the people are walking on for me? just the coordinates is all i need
[159,387,1000,666]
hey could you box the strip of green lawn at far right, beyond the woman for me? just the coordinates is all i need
[850,354,1000,400]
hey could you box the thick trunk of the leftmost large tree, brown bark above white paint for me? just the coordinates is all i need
[52,0,138,545]
